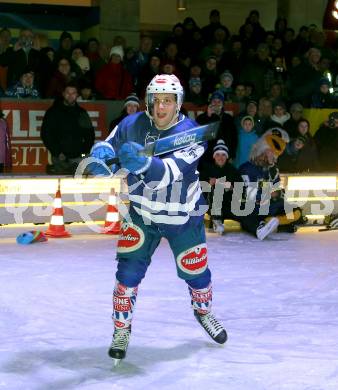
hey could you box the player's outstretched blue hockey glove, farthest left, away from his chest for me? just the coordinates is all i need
[87,141,116,176]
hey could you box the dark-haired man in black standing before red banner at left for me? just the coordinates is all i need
[41,83,95,174]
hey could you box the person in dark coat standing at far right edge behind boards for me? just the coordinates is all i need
[314,112,338,172]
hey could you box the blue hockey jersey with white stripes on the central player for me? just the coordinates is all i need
[106,112,207,225]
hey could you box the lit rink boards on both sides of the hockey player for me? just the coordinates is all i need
[0,174,338,225]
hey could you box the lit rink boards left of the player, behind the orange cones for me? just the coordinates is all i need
[0,176,126,225]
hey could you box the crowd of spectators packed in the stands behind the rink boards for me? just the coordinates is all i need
[0,9,338,172]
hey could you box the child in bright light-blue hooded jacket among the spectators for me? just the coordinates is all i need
[234,115,258,168]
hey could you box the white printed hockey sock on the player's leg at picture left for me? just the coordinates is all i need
[113,280,137,329]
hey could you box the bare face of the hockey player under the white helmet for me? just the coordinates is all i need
[153,93,177,129]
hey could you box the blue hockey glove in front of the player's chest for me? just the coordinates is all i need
[118,142,151,175]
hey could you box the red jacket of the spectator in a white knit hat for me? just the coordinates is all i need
[95,63,133,100]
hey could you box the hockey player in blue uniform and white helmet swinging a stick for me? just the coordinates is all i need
[87,75,227,362]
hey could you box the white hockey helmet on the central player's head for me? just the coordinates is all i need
[146,74,184,118]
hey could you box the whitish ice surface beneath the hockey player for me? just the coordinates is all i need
[0,227,338,390]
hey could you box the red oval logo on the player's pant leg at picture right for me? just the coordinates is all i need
[176,244,208,275]
